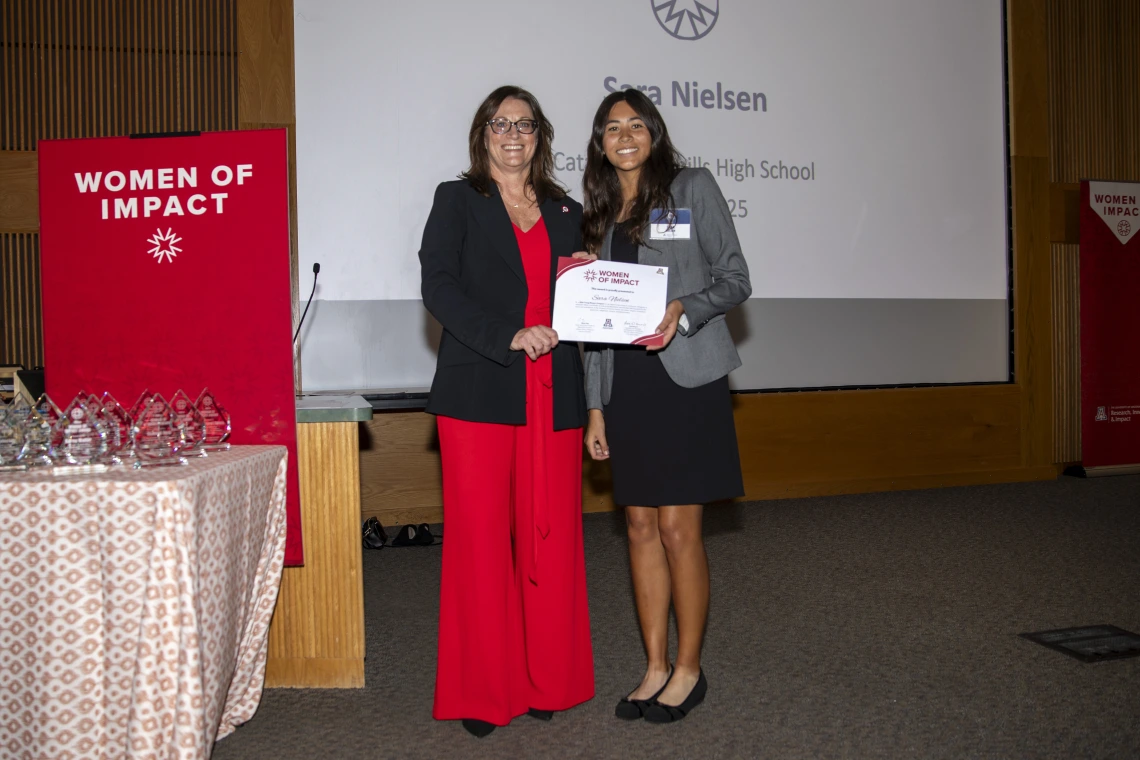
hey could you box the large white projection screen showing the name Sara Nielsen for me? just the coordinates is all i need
[294,0,1010,391]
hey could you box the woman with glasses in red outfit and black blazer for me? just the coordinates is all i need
[420,87,594,736]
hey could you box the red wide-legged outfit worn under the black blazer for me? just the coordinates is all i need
[432,218,594,726]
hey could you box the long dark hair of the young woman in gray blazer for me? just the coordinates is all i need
[581,89,685,253]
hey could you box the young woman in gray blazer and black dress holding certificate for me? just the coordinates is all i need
[583,90,751,722]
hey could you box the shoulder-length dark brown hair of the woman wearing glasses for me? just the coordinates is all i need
[459,84,567,203]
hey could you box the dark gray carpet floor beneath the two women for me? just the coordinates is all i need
[213,477,1140,760]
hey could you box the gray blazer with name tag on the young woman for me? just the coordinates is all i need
[585,169,752,409]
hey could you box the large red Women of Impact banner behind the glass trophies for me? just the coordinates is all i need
[39,130,303,565]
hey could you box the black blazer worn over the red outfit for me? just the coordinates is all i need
[420,180,586,430]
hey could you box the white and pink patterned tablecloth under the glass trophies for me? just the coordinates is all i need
[0,446,286,760]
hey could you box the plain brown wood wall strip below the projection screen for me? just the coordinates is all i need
[360,385,1057,526]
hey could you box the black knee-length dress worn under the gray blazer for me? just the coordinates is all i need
[603,216,744,507]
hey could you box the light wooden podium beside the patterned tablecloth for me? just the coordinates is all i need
[266,395,372,688]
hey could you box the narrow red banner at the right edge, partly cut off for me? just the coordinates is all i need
[1081,181,1140,467]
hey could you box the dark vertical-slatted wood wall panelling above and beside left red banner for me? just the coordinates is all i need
[0,0,238,366]
